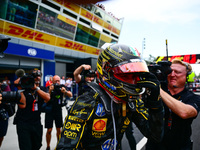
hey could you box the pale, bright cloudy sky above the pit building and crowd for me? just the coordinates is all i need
[100,0,200,72]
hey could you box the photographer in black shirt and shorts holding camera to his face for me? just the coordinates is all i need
[45,75,72,150]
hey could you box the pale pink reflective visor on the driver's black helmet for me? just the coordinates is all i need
[113,59,149,74]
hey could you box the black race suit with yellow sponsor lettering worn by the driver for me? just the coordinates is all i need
[56,82,164,150]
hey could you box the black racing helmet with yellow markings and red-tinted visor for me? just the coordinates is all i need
[97,44,149,102]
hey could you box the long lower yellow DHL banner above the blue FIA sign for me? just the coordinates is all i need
[0,20,99,55]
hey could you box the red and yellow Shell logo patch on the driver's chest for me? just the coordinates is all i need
[92,119,107,131]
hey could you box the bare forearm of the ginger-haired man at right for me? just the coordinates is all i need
[160,89,197,119]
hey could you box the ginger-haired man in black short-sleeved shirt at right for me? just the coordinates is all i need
[147,59,200,150]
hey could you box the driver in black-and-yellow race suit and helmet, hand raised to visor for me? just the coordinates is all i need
[56,44,164,150]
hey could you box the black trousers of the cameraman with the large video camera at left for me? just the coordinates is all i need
[16,123,43,150]
